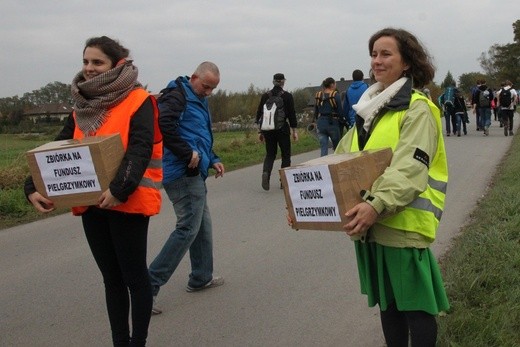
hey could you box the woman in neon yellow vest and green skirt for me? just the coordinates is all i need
[336,28,449,346]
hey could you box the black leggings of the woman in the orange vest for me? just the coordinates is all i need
[82,207,152,346]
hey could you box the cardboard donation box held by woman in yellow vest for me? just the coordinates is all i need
[280,148,392,231]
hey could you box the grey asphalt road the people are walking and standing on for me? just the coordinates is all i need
[0,116,518,347]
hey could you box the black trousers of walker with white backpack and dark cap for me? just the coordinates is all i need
[263,125,291,176]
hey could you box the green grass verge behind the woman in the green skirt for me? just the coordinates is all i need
[438,137,520,347]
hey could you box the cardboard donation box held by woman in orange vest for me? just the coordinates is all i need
[26,134,124,207]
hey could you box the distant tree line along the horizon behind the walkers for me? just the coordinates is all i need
[0,19,520,133]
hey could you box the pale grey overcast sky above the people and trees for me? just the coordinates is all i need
[0,0,520,97]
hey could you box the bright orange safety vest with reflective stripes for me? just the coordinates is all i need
[72,89,162,216]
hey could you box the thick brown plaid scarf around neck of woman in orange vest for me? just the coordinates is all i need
[71,60,141,136]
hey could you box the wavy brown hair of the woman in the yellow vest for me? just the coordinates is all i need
[368,28,435,88]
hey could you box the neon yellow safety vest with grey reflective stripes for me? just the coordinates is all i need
[351,92,448,240]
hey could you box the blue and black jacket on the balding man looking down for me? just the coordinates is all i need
[158,77,220,183]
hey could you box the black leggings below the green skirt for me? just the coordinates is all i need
[381,303,437,347]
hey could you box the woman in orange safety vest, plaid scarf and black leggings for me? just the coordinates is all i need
[25,36,162,346]
